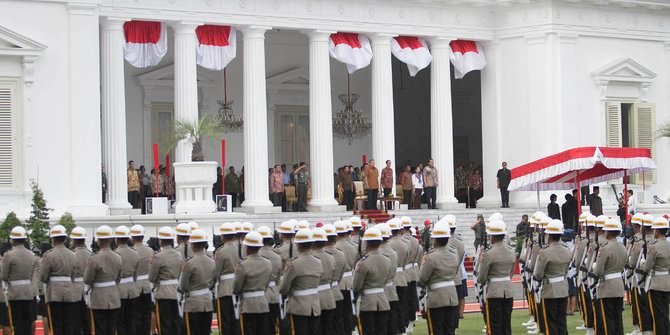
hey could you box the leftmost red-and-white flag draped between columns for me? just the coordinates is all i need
[123,21,167,68]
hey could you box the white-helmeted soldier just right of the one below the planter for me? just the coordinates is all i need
[212,222,240,335]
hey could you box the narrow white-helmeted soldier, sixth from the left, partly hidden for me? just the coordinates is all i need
[130,225,154,335]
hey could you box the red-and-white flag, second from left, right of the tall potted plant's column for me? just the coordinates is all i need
[195,25,237,70]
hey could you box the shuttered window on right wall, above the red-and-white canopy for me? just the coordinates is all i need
[606,102,656,185]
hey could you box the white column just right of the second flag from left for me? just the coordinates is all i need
[242,26,272,212]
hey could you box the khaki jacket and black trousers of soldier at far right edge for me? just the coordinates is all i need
[642,238,670,334]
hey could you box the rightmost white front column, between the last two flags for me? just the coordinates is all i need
[430,37,458,208]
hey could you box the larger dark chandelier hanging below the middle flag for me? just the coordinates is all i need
[333,74,372,145]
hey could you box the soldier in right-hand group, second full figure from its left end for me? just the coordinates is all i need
[533,220,572,335]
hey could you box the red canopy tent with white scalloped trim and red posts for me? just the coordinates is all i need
[508,147,656,212]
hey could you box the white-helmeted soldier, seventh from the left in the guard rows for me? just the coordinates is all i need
[149,227,184,335]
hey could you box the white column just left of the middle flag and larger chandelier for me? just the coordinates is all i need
[308,31,345,211]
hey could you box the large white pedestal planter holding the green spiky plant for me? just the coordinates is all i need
[174,162,219,214]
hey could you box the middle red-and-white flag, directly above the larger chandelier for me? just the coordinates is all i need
[329,33,372,74]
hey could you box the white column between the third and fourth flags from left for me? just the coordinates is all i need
[369,34,397,194]
